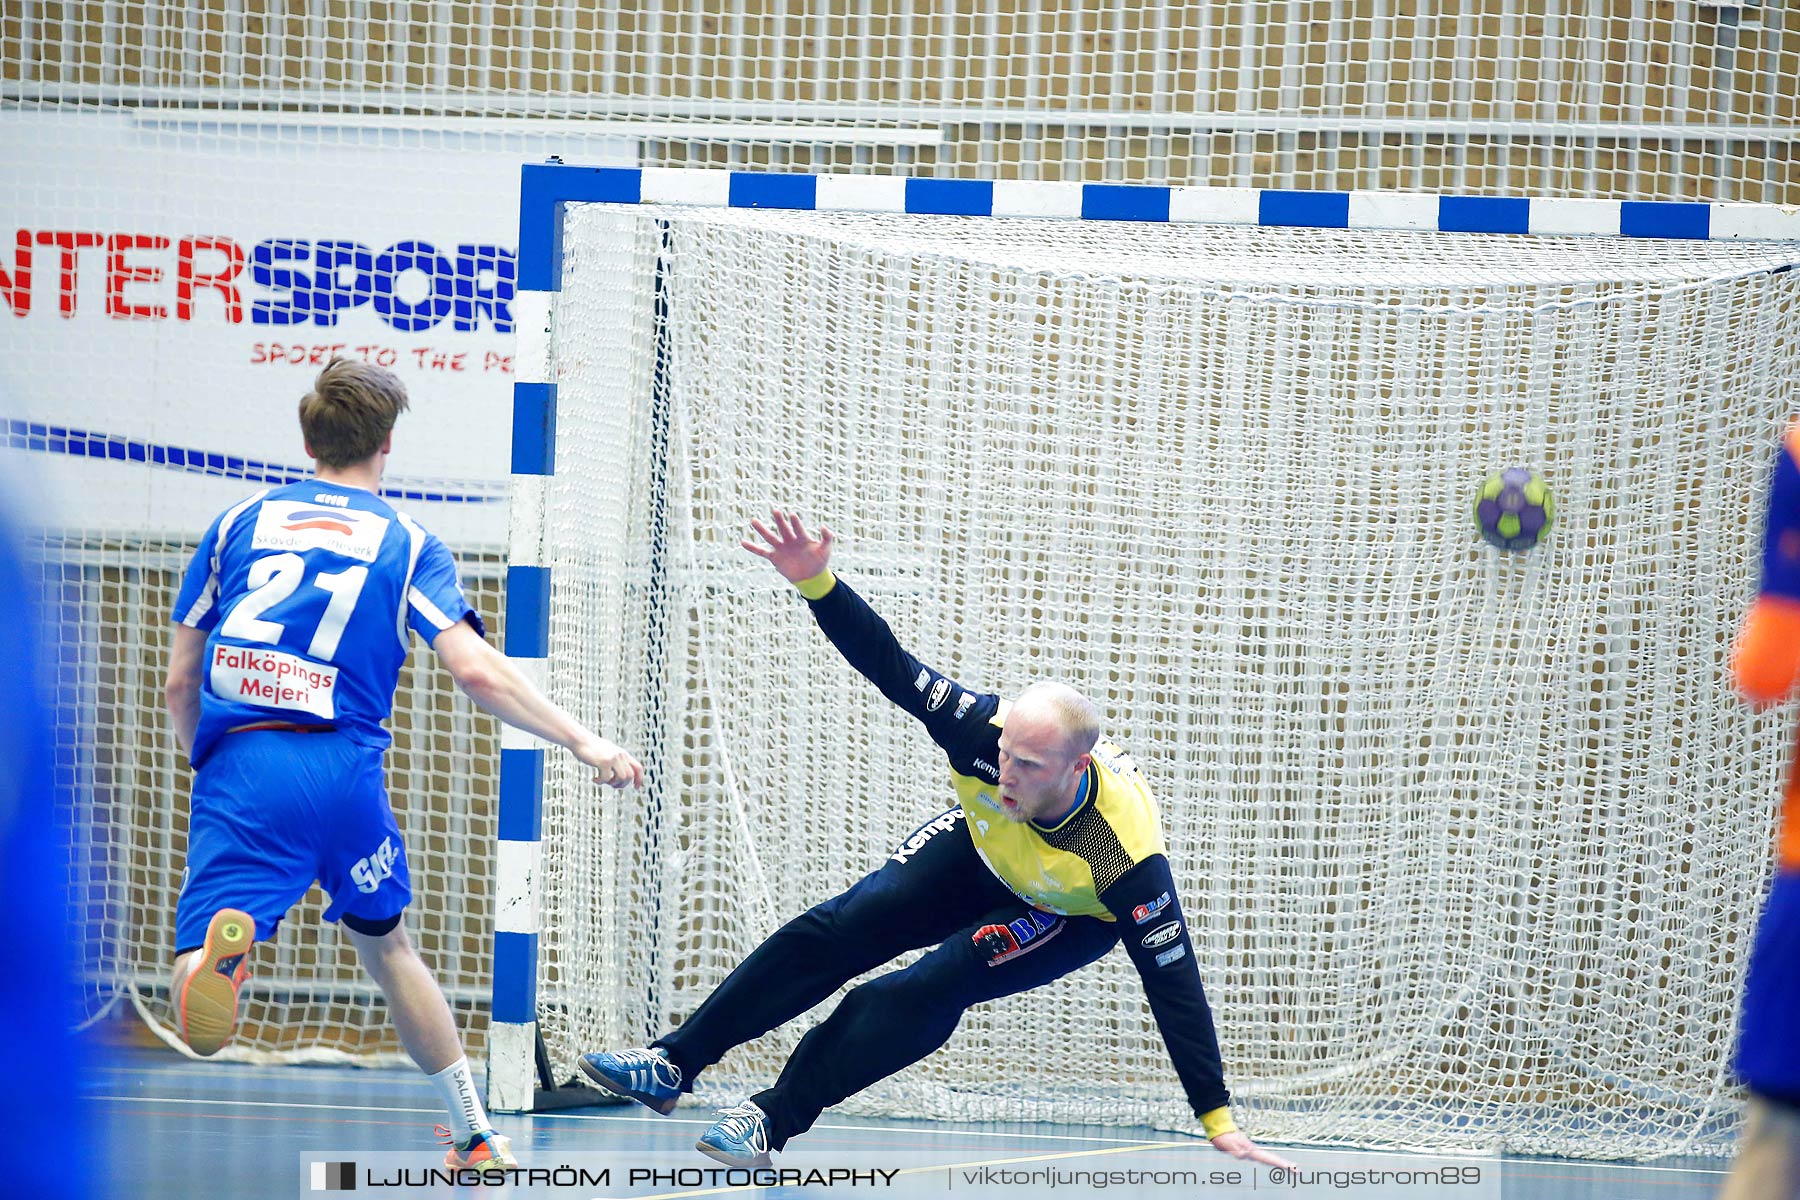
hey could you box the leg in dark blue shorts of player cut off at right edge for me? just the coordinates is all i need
[1723,871,1800,1200]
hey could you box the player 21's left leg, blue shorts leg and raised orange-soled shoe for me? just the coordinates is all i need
[169,732,315,1054]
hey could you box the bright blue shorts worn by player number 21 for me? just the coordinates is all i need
[175,730,412,954]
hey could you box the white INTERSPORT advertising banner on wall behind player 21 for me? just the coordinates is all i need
[0,112,635,549]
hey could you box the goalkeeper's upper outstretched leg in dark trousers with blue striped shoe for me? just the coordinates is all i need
[581,808,1013,1112]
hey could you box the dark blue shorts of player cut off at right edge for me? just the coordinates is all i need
[1737,871,1800,1105]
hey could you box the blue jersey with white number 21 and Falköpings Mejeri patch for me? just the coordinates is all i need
[175,479,484,766]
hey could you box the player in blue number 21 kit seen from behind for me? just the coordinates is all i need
[167,360,643,1166]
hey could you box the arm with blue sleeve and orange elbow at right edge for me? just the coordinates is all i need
[1732,425,1800,705]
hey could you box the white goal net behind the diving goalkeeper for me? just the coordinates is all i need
[540,207,1800,1157]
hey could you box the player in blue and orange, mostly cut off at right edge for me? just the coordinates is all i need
[1721,421,1800,1200]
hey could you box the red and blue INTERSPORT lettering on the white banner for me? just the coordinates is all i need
[0,228,518,333]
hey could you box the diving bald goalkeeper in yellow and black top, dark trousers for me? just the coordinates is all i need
[581,511,1289,1166]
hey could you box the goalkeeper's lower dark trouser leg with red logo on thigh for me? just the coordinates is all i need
[720,901,1120,1160]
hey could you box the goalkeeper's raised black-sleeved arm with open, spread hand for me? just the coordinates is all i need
[740,509,999,750]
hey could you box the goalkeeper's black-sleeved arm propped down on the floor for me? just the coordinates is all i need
[1100,855,1292,1166]
